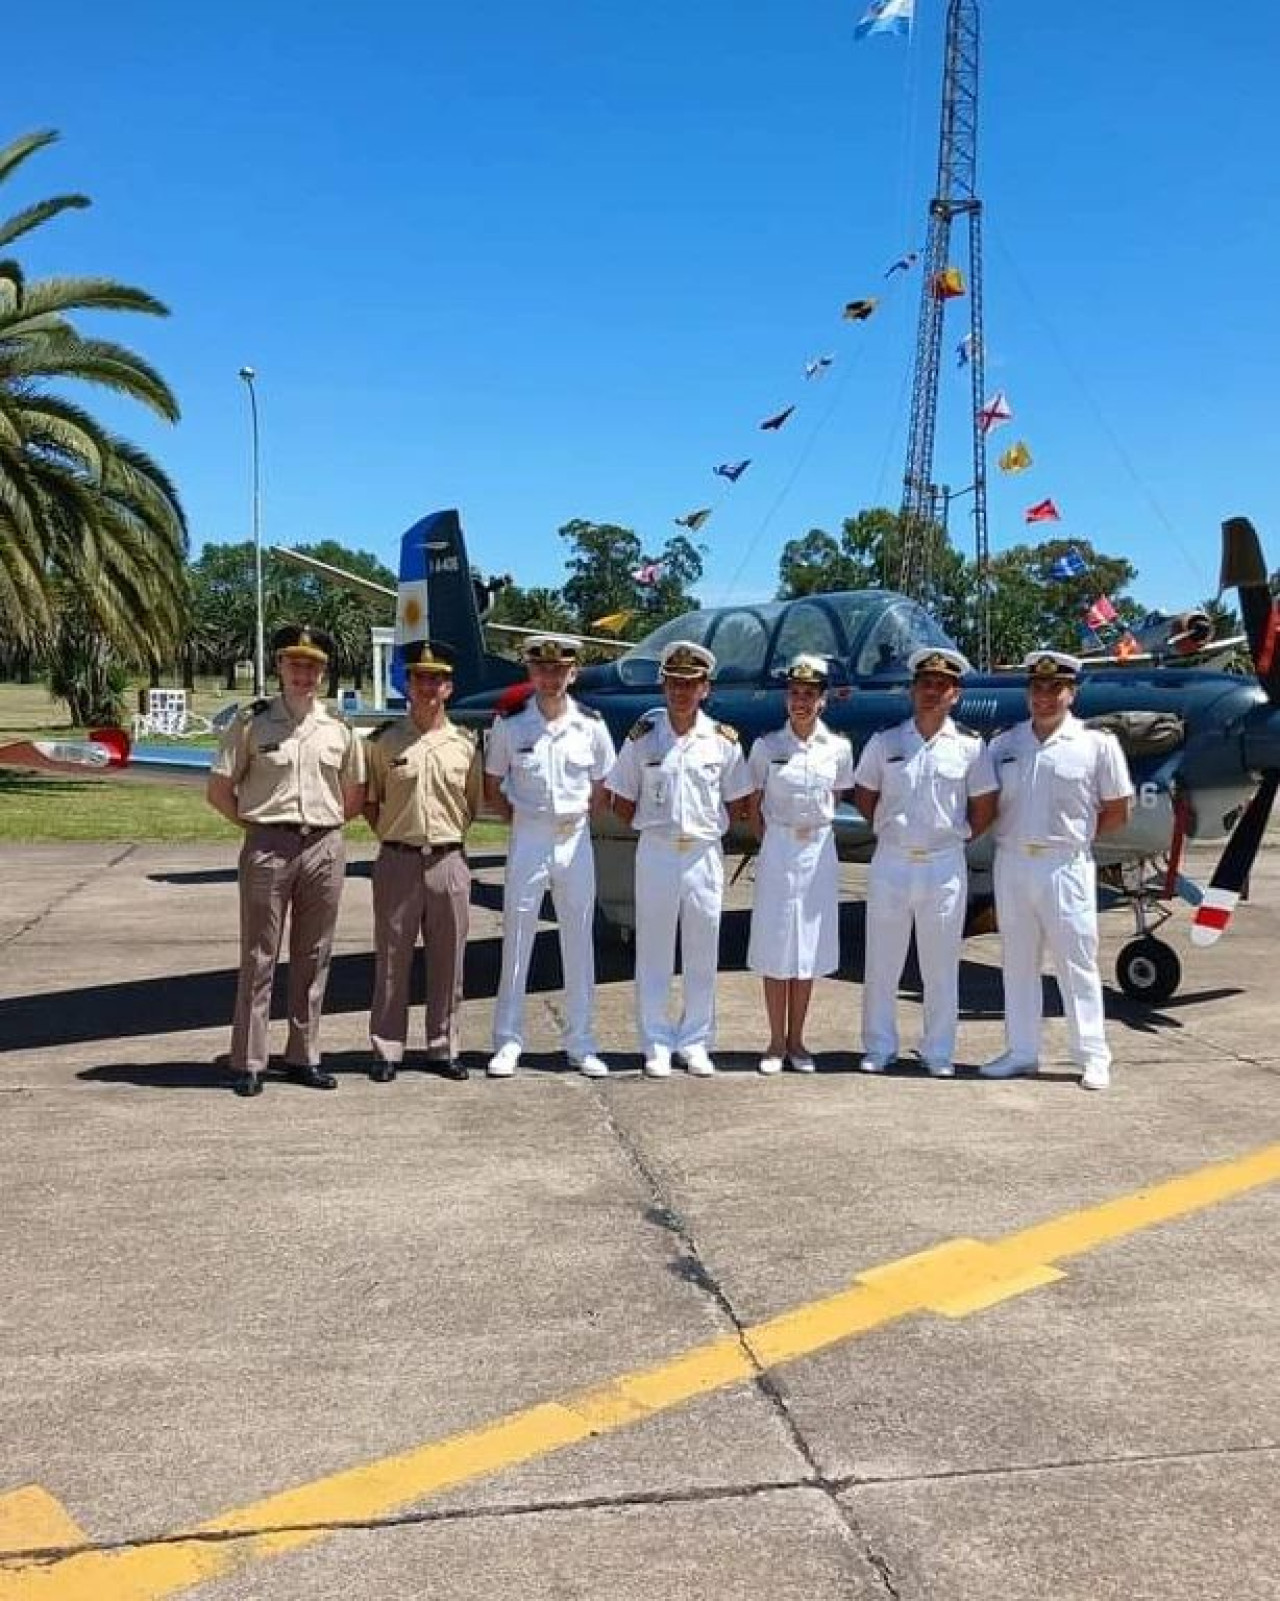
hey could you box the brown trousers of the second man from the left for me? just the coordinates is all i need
[370,845,470,1063]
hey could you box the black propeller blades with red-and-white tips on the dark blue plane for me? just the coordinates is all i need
[1190,517,1280,945]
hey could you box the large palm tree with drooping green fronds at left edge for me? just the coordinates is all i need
[0,131,187,661]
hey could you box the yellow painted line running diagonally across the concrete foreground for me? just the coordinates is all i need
[0,1143,1280,1601]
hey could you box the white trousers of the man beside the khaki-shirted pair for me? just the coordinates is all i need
[493,817,595,1057]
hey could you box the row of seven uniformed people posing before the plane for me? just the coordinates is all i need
[208,626,1133,1095]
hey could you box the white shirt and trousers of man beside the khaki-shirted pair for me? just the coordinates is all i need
[485,696,614,1057]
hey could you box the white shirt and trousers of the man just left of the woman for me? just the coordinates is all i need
[608,708,755,1057]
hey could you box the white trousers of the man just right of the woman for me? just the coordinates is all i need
[862,845,968,1063]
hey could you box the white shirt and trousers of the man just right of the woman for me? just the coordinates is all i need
[853,717,995,1066]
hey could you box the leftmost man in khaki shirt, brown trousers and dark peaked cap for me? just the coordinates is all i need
[206,624,365,1095]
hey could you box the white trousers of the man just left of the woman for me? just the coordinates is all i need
[635,829,725,1055]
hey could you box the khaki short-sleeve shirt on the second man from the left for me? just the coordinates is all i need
[368,717,483,845]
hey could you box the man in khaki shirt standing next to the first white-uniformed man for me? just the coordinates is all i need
[365,639,483,1084]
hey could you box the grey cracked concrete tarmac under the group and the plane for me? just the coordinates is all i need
[0,844,1280,1601]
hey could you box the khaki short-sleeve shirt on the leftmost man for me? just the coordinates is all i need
[211,695,365,828]
